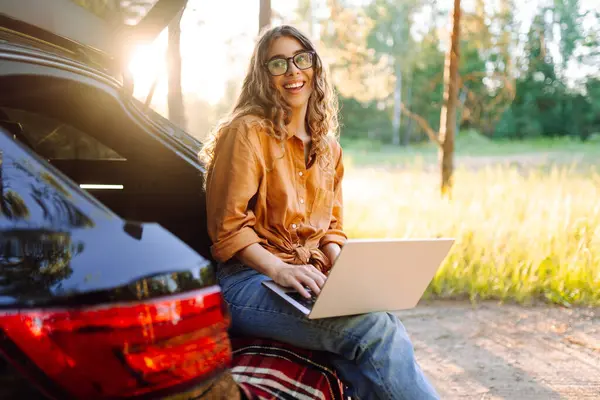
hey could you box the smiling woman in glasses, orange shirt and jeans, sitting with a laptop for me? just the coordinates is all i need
[201,26,437,400]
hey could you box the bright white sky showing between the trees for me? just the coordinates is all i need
[130,0,599,108]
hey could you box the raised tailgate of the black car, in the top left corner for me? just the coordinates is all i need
[0,0,187,76]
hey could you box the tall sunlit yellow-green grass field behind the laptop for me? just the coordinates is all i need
[344,139,600,306]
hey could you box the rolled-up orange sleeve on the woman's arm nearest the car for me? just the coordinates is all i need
[206,123,261,262]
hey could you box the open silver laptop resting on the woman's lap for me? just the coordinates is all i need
[263,238,454,319]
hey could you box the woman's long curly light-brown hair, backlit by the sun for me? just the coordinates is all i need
[199,25,339,171]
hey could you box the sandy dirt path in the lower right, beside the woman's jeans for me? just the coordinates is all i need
[399,302,600,400]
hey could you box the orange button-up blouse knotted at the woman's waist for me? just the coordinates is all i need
[206,116,347,271]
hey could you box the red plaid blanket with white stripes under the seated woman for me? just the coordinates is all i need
[231,337,345,400]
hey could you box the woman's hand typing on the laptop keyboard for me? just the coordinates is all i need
[271,263,327,299]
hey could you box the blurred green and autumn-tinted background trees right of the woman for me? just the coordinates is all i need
[330,0,600,144]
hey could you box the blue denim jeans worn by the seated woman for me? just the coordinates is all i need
[217,264,439,400]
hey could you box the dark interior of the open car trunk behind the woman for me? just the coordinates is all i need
[0,76,211,259]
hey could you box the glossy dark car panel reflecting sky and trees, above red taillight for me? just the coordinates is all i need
[0,128,215,307]
